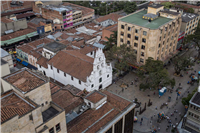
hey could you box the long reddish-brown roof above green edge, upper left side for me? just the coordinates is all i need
[0,28,35,41]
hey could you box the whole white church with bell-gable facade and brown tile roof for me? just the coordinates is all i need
[37,49,112,91]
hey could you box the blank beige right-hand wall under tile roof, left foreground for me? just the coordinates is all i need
[25,82,52,111]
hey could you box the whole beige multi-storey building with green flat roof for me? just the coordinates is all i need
[117,4,182,64]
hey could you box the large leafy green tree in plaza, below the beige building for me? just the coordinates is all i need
[137,57,175,90]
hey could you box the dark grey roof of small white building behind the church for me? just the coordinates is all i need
[44,41,67,53]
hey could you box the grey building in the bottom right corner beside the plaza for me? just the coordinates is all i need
[182,87,200,133]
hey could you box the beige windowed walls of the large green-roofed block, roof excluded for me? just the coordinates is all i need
[117,13,182,64]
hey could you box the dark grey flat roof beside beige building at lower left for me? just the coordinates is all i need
[42,107,59,123]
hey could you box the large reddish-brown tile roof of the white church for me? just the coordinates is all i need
[48,50,94,82]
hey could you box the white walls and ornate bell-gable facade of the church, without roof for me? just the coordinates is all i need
[37,50,112,91]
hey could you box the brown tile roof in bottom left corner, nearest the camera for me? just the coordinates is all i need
[0,91,36,124]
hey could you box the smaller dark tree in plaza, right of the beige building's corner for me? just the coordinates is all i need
[172,56,194,75]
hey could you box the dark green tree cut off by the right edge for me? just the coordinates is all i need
[184,25,200,59]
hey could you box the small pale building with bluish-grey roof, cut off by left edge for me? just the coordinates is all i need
[0,48,13,68]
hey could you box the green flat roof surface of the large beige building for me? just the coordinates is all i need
[119,10,173,29]
